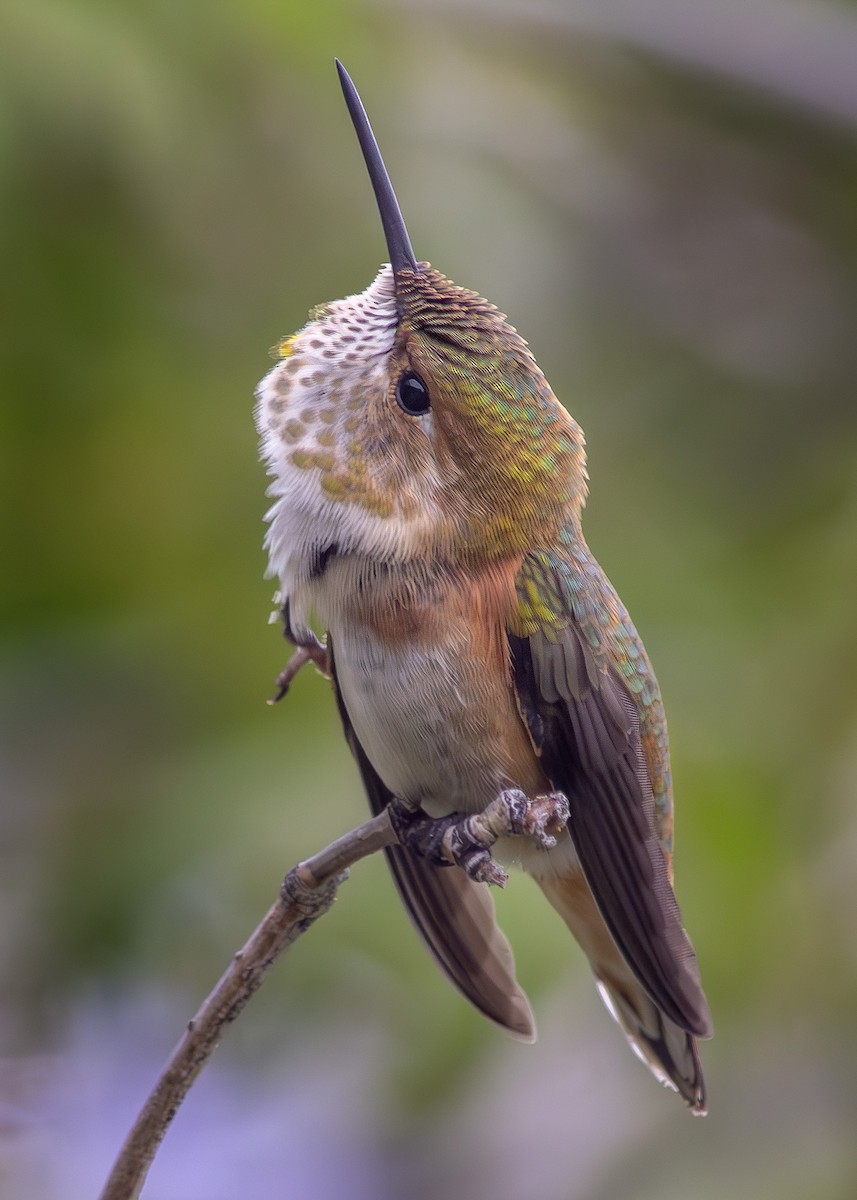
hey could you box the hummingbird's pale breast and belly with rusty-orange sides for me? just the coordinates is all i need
[317,559,541,816]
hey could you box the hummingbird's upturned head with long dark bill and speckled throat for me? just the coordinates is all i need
[257,66,586,590]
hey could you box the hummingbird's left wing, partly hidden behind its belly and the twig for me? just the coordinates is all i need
[328,641,535,1042]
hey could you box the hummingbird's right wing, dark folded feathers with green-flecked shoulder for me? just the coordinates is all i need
[509,553,712,1037]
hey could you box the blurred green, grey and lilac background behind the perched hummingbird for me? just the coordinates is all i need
[0,0,857,1200]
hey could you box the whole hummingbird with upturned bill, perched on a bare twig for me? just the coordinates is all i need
[256,61,713,1114]
